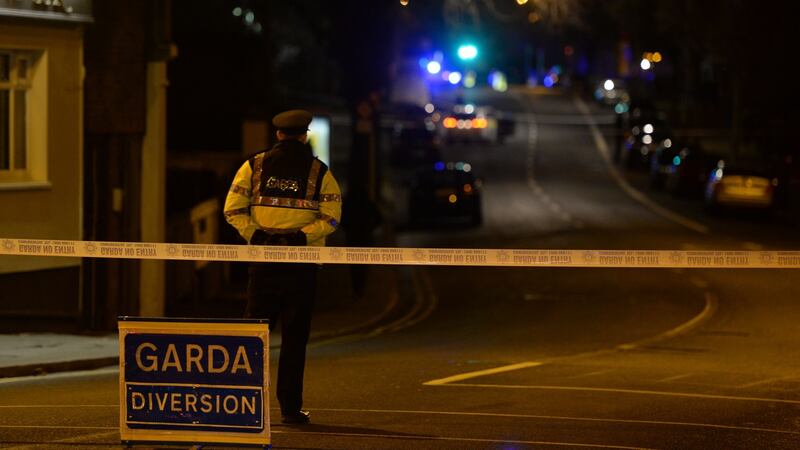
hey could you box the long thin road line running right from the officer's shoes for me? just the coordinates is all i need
[306,408,800,435]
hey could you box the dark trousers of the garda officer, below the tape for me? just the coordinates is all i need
[245,263,319,414]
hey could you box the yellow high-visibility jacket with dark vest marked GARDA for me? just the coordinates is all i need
[225,141,342,246]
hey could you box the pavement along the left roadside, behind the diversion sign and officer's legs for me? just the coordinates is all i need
[0,265,402,378]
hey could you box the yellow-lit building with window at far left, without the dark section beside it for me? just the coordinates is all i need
[0,0,92,326]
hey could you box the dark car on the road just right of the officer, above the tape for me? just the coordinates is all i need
[408,161,483,226]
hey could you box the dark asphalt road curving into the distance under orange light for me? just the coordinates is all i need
[0,89,800,449]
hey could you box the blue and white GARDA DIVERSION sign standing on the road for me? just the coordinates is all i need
[118,317,271,448]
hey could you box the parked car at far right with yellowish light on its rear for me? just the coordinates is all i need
[705,160,778,211]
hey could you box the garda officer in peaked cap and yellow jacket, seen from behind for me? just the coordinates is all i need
[225,110,342,423]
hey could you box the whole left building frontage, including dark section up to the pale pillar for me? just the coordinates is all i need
[0,0,173,332]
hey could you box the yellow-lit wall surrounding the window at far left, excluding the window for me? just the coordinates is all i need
[0,18,83,316]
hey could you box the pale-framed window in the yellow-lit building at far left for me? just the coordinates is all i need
[0,49,46,183]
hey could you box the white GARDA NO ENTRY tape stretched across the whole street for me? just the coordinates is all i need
[0,238,800,269]
